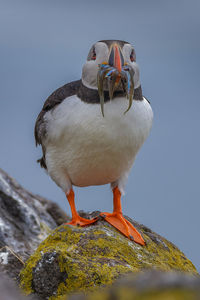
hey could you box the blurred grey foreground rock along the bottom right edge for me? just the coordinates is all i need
[67,270,200,300]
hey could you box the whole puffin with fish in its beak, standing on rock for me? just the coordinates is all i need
[35,40,153,245]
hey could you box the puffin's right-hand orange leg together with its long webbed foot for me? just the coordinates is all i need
[101,187,145,245]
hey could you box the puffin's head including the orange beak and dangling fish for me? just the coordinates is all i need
[82,40,140,113]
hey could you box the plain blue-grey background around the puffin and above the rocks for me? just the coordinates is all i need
[0,0,200,271]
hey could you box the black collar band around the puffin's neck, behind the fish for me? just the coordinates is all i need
[77,81,143,104]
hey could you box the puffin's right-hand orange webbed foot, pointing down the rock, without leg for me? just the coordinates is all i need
[100,212,145,246]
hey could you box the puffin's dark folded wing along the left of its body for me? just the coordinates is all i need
[34,80,81,169]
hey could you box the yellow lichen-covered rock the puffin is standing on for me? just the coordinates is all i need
[21,212,197,300]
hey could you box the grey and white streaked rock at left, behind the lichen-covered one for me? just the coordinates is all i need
[0,169,68,279]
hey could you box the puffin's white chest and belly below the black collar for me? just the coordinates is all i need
[45,96,153,186]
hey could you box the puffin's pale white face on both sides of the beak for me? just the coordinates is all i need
[82,41,140,89]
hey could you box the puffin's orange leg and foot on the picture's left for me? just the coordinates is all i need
[65,189,97,226]
